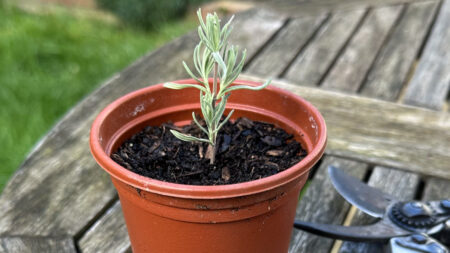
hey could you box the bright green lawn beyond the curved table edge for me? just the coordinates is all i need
[0,7,195,191]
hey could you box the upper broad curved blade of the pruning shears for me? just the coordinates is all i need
[328,166,397,218]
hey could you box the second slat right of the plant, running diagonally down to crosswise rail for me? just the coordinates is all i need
[283,10,365,86]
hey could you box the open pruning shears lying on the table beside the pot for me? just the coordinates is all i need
[294,166,450,253]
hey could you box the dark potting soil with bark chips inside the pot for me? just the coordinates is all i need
[111,117,306,185]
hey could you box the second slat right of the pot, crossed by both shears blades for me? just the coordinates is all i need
[339,167,419,253]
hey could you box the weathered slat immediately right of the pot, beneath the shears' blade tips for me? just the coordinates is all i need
[289,156,367,253]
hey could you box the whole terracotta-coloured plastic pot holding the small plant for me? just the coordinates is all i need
[90,80,326,253]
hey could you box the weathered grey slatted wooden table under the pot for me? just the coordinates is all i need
[0,0,450,252]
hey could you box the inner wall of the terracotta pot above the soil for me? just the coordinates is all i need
[99,83,320,156]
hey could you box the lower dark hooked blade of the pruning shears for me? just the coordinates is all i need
[294,219,411,242]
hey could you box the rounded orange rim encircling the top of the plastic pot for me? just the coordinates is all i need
[89,79,327,199]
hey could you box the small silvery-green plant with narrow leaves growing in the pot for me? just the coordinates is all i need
[164,9,270,147]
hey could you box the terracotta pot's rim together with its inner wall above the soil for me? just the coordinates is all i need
[90,80,326,199]
